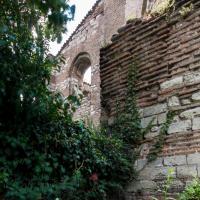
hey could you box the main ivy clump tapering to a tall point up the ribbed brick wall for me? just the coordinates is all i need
[111,62,144,145]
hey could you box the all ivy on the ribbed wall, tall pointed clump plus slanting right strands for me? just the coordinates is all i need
[111,61,175,162]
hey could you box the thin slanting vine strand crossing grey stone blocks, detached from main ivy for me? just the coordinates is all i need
[147,112,175,162]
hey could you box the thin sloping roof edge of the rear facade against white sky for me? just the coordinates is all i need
[57,0,102,56]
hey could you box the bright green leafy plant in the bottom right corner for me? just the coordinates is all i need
[179,179,200,200]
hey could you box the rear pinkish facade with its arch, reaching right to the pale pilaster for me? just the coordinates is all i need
[51,0,159,124]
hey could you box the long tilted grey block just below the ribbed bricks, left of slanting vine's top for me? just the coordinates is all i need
[143,103,167,117]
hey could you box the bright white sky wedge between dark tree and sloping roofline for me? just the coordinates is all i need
[50,0,97,55]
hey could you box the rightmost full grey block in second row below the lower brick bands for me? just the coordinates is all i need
[177,165,197,178]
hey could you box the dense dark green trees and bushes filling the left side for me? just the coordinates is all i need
[0,0,136,200]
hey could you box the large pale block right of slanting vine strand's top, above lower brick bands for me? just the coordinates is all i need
[167,120,192,134]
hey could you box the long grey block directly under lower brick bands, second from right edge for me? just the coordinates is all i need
[164,155,187,166]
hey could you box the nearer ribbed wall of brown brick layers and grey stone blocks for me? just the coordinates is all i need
[100,0,200,200]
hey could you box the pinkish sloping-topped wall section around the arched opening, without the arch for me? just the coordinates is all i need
[52,1,104,123]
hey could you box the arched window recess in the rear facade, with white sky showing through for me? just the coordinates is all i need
[70,52,91,95]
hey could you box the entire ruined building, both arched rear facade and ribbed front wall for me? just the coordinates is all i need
[53,0,200,200]
